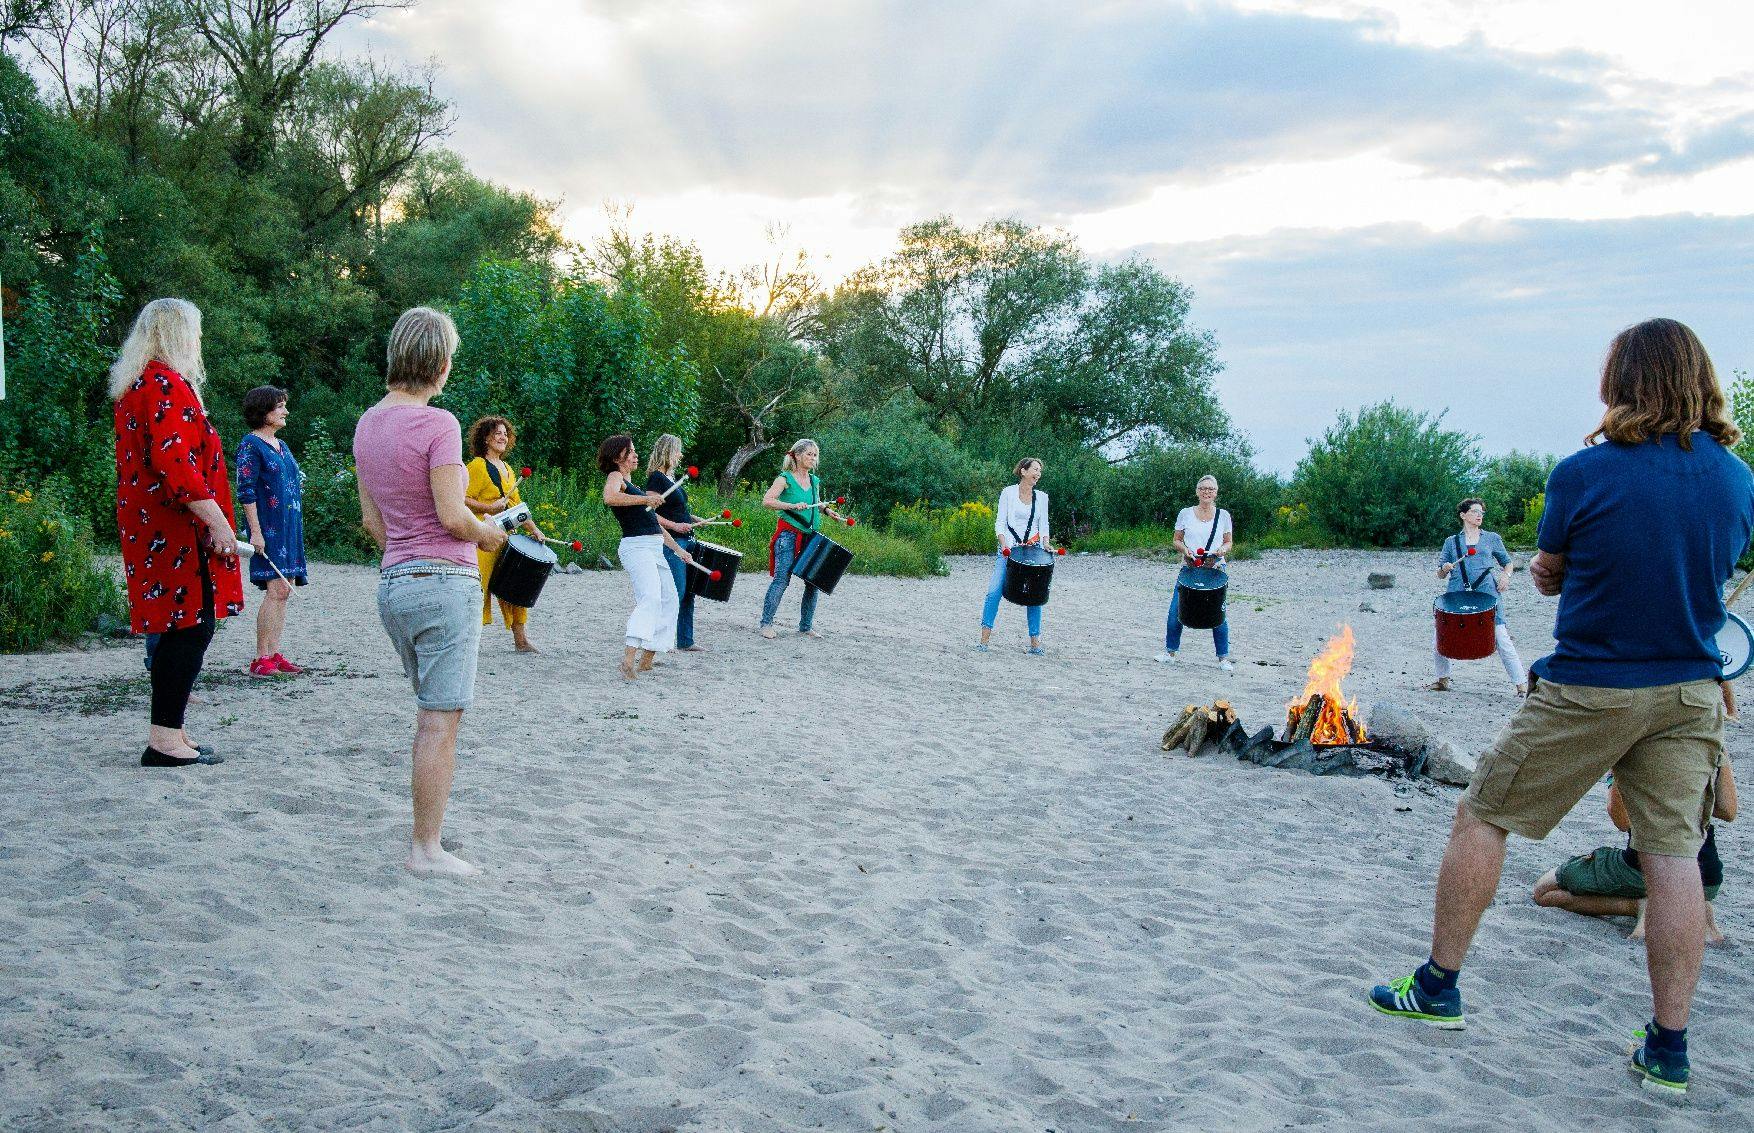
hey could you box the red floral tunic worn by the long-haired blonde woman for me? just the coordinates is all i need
[116,361,244,633]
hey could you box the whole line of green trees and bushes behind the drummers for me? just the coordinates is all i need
[0,0,1711,578]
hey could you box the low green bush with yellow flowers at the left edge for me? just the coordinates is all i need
[0,479,128,652]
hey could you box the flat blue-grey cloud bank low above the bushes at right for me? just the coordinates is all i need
[1135,217,1754,472]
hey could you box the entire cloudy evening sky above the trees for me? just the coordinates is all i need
[339,0,1754,472]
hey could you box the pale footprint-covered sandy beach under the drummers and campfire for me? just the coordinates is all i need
[0,552,1754,1133]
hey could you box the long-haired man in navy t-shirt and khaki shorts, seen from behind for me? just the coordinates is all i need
[1370,319,1754,1093]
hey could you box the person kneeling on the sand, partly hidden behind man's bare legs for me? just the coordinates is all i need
[1535,756,1736,944]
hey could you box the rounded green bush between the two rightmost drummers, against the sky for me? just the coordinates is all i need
[1291,402,1480,547]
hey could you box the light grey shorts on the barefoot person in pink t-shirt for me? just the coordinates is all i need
[377,563,481,712]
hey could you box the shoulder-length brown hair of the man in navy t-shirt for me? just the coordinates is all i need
[1584,319,1742,451]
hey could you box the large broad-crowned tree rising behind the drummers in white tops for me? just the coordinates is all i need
[821,217,1228,460]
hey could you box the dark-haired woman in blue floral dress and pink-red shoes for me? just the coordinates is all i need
[237,386,309,677]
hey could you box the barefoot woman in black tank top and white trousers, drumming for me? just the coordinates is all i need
[596,433,695,681]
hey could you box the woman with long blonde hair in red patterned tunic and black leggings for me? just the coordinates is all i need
[111,298,244,766]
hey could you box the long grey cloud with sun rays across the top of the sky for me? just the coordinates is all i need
[342,0,1754,219]
